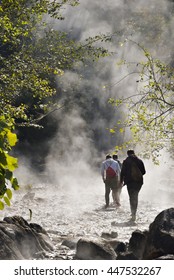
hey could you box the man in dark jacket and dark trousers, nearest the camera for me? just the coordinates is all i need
[120,150,146,221]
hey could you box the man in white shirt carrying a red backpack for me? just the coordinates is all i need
[101,155,121,208]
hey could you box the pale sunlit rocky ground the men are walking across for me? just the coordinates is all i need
[1,174,174,259]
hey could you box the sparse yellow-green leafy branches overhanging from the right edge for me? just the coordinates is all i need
[109,44,174,163]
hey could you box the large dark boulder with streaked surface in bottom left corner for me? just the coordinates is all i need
[0,216,53,260]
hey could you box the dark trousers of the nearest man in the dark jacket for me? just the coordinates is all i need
[127,182,142,216]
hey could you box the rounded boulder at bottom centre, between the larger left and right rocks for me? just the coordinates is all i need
[75,238,116,260]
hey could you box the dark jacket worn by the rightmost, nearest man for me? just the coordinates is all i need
[120,155,146,185]
